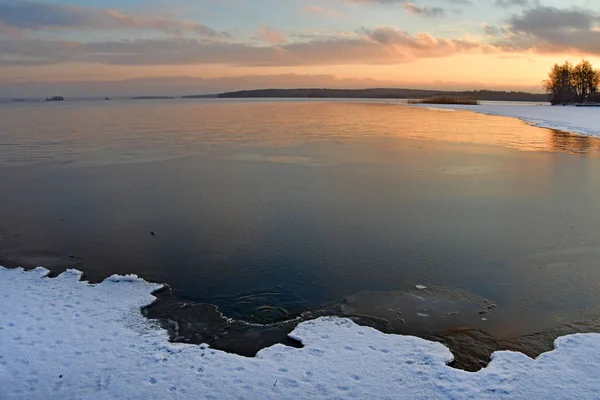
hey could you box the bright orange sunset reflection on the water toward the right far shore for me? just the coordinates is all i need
[185,101,600,158]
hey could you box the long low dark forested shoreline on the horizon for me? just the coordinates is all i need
[185,89,549,102]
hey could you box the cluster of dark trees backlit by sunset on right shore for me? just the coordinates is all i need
[543,60,600,104]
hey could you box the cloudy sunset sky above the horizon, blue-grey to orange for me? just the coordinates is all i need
[0,0,600,97]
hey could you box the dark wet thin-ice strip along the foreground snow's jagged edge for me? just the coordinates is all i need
[142,288,600,372]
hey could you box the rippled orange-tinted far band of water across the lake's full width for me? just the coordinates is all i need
[0,100,600,166]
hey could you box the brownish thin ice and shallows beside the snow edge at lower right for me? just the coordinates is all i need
[329,288,600,372]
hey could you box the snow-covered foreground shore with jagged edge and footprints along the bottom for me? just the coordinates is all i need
[0,267,600,400]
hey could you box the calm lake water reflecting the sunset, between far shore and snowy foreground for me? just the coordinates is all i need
[0,100,600,337]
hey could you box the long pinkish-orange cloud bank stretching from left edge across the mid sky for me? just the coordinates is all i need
[0,26,497,67]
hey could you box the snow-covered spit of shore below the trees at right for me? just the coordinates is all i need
[418,103,600,137]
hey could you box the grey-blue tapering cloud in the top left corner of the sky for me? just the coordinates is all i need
[0,0,229,37]
